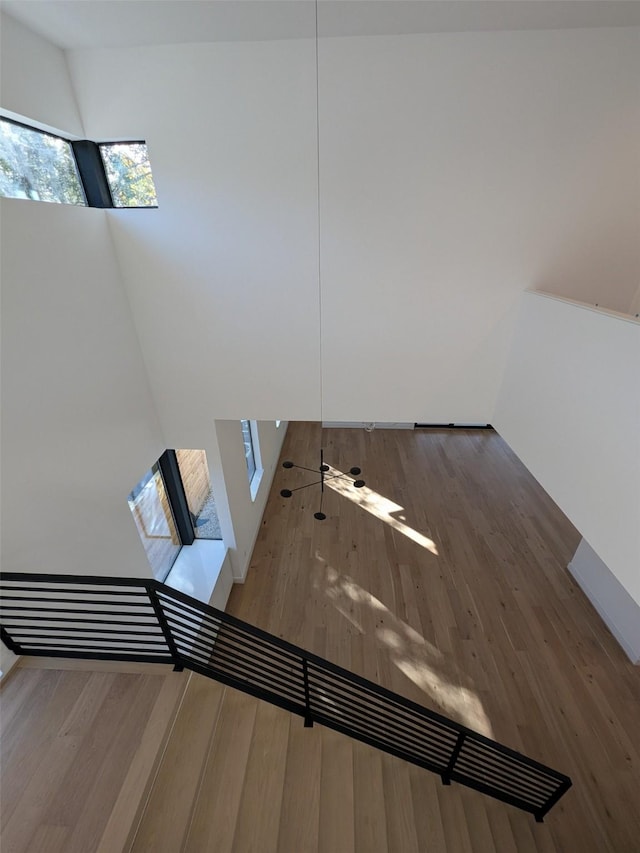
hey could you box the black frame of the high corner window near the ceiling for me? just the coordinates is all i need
[0,115,158,210]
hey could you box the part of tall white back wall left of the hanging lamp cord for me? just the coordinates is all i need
[66,41,319,433]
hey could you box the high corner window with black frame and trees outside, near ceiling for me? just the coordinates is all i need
[0,116,158,209]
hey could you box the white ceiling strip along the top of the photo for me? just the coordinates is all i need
[0,0,640,48]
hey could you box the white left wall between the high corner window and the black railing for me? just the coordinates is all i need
[0,199,165,577]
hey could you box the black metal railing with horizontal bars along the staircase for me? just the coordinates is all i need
[0,572,571,821]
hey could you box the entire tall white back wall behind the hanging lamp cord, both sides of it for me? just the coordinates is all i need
[70,28,640,429]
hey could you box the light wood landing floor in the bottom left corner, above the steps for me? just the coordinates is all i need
[0,662,187,853]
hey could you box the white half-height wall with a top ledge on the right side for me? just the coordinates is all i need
[491,293,640,604]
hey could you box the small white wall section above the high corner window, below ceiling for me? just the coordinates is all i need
[0,13,84,137]
